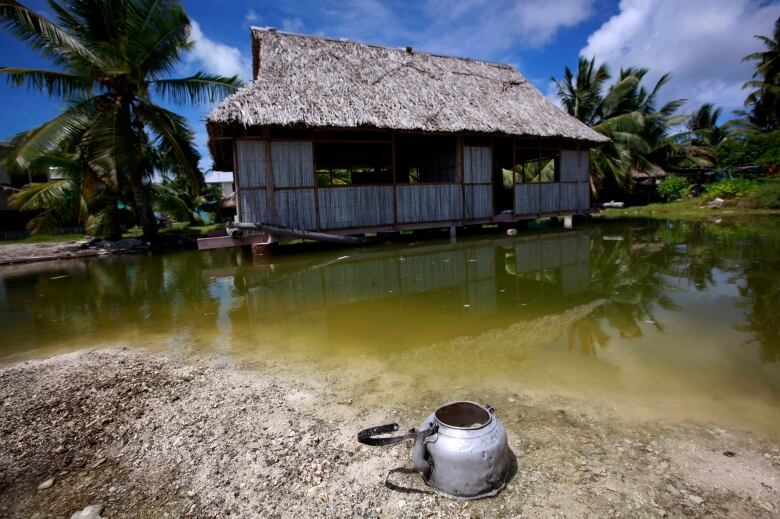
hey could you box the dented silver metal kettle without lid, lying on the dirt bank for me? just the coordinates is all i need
[358,402,512,499]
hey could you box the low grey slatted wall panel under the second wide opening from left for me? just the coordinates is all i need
[396,184,463,223]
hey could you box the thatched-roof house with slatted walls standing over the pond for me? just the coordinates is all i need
[207,28,606,238]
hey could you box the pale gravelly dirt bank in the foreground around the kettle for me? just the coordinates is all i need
[0,350,780,518]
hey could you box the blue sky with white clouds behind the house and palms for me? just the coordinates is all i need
[0,0,780,169]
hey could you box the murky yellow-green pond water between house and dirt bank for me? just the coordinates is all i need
[0,218,780,437]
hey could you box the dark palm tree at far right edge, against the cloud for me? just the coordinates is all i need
[742,17,780,131]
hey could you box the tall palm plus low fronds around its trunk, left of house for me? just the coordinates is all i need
[0,0,241,241]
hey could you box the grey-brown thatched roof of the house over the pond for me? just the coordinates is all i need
[208,27,607,142]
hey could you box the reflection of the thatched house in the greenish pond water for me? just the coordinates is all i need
[231,231,598,355]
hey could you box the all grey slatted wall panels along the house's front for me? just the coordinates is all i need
[236,140,590,230]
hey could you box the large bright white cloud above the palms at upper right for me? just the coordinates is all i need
[580,0,780,111]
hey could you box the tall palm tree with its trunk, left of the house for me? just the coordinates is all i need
[0,0,240,240]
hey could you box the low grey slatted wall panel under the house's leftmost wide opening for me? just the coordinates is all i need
[318,186,393,229]
